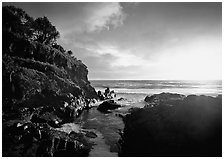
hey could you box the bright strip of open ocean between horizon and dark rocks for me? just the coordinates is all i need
[90,80,222,96]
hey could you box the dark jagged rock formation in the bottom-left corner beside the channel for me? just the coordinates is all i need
[3,120,91,157]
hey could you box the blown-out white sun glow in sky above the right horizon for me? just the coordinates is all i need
[150,36,221,80]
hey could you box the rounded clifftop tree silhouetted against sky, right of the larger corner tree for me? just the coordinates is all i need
[33,16,59,45]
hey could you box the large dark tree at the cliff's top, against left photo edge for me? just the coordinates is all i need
[2,6,34,56]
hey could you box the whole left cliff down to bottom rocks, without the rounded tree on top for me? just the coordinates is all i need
[2,7,97,156]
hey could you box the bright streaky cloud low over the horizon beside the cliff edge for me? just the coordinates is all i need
[61,33,147,79]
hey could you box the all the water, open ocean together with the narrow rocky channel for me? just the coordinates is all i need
[76,80,222,157]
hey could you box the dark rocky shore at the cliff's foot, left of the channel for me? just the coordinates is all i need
[2,88,99,157]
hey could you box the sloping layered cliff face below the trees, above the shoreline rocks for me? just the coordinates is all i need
[3,33,97,103]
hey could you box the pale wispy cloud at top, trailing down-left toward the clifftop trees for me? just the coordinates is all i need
[58,2,127,45]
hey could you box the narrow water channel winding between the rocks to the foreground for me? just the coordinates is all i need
[75,93,147,157]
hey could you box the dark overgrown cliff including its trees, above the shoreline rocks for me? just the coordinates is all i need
[2,6,97,110]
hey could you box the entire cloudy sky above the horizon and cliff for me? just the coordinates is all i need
[3,2,222,80]
